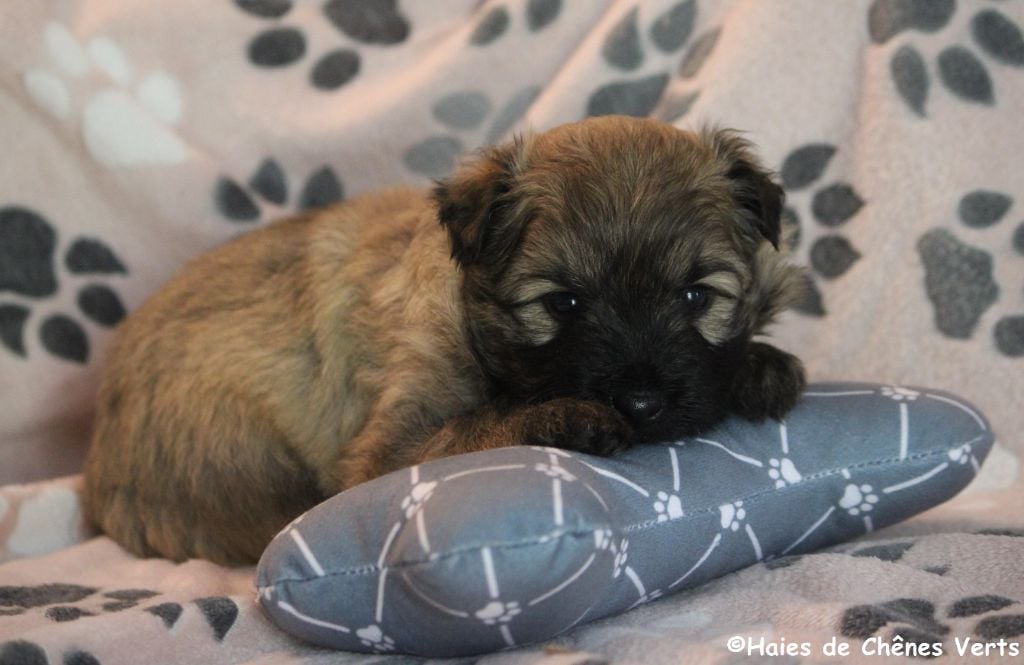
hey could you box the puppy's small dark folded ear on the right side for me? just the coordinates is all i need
[705,129,785,249]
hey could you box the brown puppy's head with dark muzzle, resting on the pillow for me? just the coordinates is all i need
[434,117,800,441]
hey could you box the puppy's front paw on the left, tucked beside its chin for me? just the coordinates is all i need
[522,398,634,456]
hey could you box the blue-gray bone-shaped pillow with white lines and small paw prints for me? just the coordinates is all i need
[257,383,993,657]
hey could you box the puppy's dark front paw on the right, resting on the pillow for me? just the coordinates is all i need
[732,342,806,420]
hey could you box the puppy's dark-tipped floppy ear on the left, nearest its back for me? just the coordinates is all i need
[433,136,528,265]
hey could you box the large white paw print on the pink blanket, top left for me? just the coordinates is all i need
[23,23,186,166]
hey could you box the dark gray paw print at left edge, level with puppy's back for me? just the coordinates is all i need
[0,205,128,364]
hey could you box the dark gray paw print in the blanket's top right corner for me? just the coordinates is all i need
[867,0,1024,117]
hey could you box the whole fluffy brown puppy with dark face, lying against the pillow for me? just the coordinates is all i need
[85,117,804,564]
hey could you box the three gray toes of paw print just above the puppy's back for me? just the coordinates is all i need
[213,157,345,222]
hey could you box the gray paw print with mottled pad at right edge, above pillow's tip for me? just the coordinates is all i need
[918,190,1024,358]
